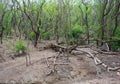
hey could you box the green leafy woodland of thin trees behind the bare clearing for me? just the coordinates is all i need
[0,0,120,51]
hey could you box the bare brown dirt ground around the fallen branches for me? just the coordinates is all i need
[0,40,120,84]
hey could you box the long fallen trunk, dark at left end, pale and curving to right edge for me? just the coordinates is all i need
[51,44,120,71]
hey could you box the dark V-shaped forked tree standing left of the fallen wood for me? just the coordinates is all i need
[16,0,45,47]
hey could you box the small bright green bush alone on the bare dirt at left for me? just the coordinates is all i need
[15,40,27,52]
